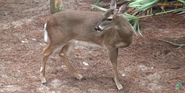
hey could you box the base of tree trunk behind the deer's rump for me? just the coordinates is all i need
[50,0,62,14]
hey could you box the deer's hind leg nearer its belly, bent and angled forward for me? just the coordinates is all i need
[59,42,82,80]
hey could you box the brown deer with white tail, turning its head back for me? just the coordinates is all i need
[40,0,134,90]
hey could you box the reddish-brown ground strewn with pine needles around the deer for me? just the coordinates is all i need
[0,0,185,93]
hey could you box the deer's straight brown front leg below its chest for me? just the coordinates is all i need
[108,47,123,90]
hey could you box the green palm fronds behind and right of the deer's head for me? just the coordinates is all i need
[93,0,185,35]
